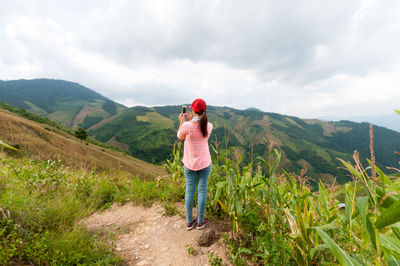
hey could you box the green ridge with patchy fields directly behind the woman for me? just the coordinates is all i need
[89,106,400,183]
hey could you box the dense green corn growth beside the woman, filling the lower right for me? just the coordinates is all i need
[164,132,400,265]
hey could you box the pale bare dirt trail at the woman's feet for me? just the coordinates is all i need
[82,204,230,265]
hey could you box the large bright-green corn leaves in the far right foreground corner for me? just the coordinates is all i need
[316,156,400,265]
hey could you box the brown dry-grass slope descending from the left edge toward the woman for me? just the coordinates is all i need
[0,109,166,179]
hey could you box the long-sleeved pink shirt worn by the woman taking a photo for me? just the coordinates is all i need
[177,121,213,171]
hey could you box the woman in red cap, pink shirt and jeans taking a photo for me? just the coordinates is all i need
[177,99,213,230]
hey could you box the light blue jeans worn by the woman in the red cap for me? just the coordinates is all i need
[184,165,211,223]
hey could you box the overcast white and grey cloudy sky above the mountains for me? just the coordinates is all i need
[0,0,400,118]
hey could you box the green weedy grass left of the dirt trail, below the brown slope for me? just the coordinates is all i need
[0,154,183,265]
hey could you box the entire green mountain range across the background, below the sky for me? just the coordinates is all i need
[0,79,400,187]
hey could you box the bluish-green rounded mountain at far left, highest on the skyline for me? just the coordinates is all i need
[0,79,126,128]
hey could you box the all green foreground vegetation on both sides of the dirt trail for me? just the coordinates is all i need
[0,104,400,265]
